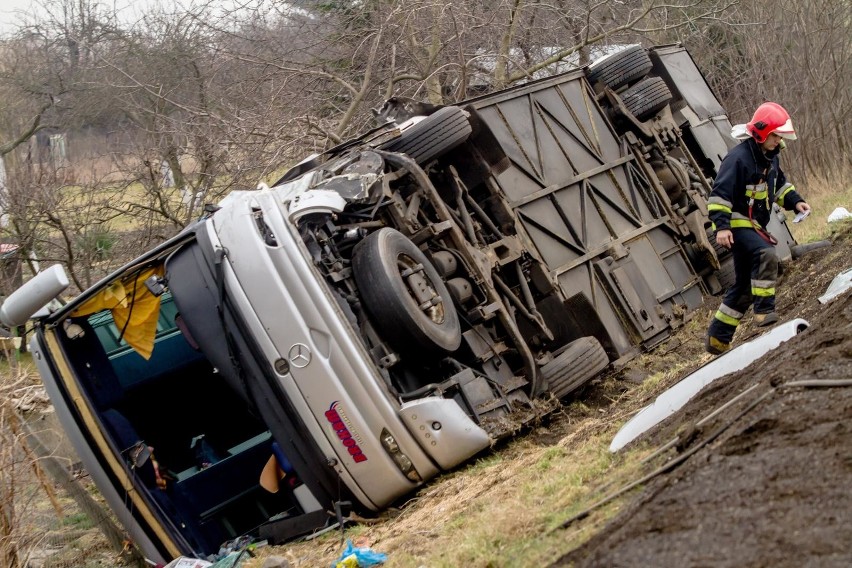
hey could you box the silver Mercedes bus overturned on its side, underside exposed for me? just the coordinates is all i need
[2,46,792,561]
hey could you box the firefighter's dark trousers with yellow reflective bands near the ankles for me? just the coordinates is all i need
[707,229,778,344]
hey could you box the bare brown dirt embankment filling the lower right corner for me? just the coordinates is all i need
[555,228,852,567]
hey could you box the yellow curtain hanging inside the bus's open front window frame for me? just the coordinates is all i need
[71,264,163,360]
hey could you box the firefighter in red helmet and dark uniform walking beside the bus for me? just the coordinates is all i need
[706,102,811,355]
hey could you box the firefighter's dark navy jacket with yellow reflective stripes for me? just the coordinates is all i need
[707,138,804,231]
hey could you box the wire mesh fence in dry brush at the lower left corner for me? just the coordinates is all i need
[0,359,144,568]
